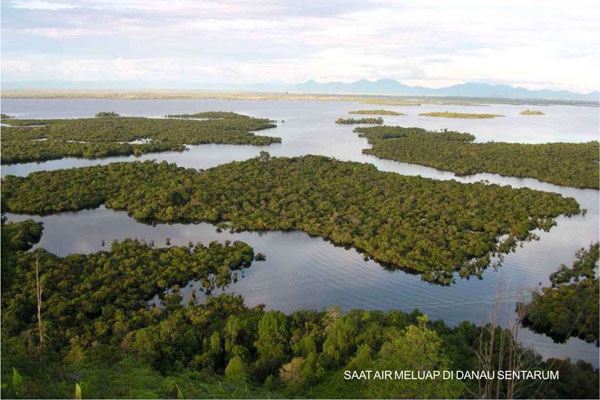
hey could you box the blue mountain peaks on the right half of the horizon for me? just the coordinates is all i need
[292,79,600,101]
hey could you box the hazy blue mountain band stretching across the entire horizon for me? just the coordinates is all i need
[2,79,600,102]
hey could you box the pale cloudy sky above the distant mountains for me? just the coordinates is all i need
[0,0,600,92]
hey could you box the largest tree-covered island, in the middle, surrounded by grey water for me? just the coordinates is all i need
[2,156,580,284]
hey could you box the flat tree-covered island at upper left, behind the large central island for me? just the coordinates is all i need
[2,112,281,164]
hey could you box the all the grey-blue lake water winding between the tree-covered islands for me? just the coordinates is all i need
[2,99,600,366]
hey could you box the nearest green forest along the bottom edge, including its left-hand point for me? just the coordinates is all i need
[2,218,598,398]
